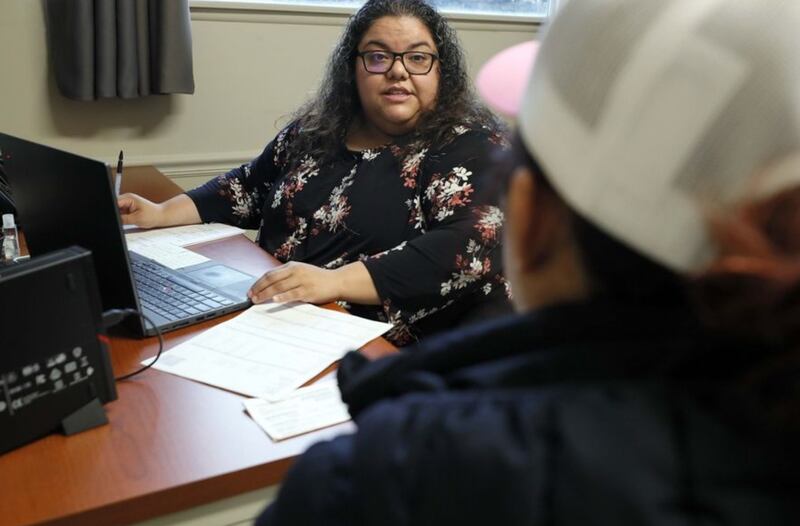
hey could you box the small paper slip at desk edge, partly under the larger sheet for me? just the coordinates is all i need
[244,382,350,441]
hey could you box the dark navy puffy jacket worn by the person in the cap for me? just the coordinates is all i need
[258,301,800,526]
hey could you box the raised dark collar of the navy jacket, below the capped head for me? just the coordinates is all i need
[339,298,776,415]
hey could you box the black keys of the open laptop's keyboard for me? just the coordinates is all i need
[131,258,233,321]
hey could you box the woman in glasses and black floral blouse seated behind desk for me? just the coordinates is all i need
[119,0,511,344]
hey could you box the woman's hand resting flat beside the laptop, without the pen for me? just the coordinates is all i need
[247,261,341,304]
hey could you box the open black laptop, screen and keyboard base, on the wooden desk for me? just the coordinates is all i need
[0,133,257,336]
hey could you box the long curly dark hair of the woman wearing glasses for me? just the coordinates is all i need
[288,0,502,163]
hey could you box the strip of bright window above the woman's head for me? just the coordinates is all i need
[192,0,564,19]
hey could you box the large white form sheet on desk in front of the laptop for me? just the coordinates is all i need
[148,303,392,400]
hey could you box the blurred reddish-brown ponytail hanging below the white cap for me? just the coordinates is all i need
[689,187,800,430]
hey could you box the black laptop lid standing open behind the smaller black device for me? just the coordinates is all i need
[0,133,137,310]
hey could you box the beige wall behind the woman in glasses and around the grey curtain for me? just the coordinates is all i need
[0,0,536,191]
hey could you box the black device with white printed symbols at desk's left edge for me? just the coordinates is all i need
[0,247,117,454]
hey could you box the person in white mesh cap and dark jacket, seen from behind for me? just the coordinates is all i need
[258,0,800,526]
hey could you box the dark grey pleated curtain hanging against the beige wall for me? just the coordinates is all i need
[44,0,194,100]
